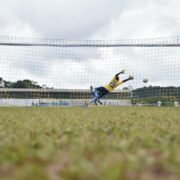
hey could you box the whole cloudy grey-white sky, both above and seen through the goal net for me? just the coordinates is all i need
[0,0,180,88]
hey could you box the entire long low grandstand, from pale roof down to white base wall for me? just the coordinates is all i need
[0,88,132,106]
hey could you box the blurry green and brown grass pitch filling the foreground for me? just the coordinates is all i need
[0,107,180,180]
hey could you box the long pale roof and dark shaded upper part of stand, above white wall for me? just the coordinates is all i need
[0,88,132,99]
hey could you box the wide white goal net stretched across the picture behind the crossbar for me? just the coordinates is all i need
[0,36,180,106]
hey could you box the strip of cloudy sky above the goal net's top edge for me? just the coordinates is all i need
[0,0,180,39]
